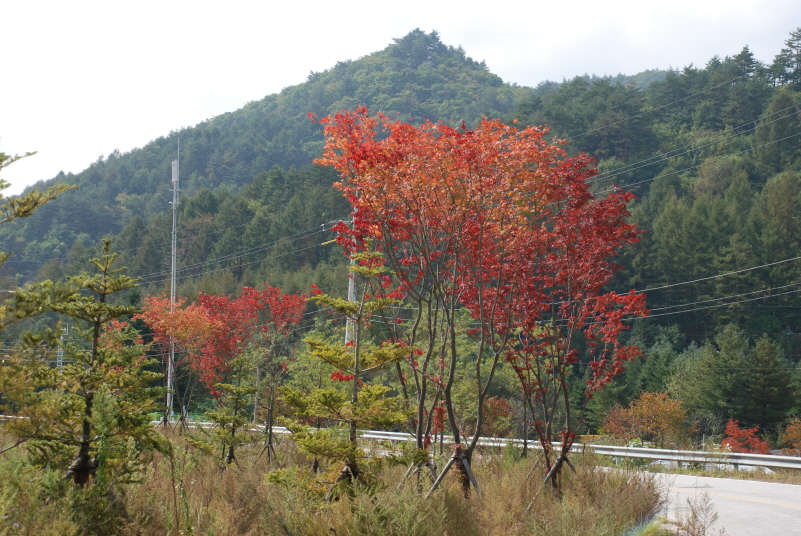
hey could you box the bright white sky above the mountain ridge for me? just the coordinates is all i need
[0,0,801,194]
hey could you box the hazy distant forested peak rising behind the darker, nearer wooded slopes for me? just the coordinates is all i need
[0,30,531,274]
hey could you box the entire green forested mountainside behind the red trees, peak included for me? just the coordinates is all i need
[0,30,801,436]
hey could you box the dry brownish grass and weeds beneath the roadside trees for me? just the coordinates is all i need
[0,436,661,536]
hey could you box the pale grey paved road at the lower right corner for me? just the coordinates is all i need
[659,474,801,536]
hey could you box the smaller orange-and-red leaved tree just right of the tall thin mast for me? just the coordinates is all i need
[140,286,307,463]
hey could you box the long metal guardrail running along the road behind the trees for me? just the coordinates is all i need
[158,421,801,470]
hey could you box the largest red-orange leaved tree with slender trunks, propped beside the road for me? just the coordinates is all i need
[318,108,645,496]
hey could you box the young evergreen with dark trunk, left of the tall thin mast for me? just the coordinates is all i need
[5,239,162,486]
